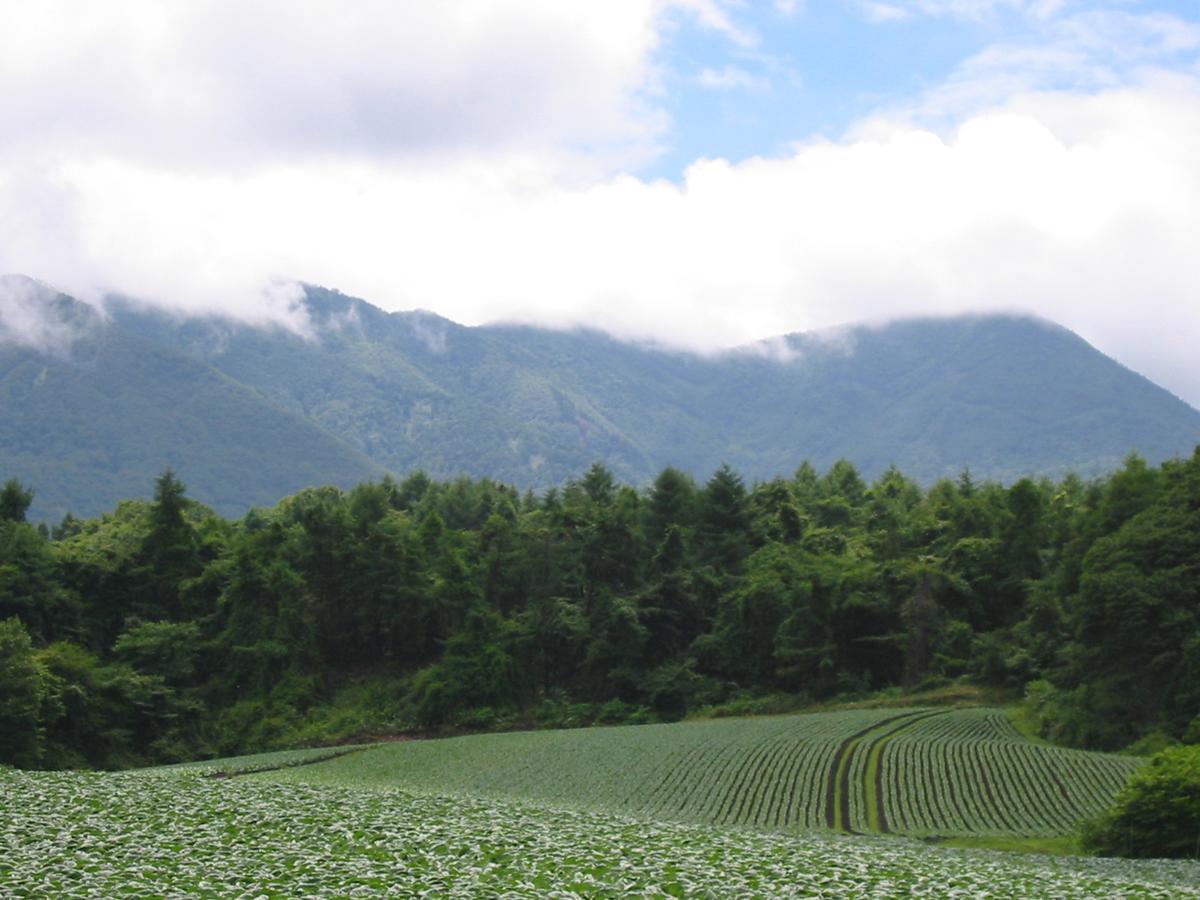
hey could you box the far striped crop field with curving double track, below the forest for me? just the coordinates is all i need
[258,709,1140,838]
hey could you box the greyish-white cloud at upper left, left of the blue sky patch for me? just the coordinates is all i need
[0,0,672,164]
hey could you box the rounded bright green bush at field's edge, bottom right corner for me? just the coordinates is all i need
[1082,745,1200,859]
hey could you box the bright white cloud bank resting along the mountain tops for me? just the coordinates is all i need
[9,78,1200,402]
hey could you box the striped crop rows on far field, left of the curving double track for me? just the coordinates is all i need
[258,710,896,828]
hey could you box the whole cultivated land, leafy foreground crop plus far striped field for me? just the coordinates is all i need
[0,709,1200,898]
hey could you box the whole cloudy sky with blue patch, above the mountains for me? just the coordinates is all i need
[0,0,1200,407]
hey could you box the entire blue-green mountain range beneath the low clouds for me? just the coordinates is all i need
[0,287,1200,518]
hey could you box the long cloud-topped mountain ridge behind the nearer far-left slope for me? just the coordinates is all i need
[119,288,1200,486]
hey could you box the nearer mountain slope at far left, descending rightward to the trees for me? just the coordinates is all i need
[0,282,383,521]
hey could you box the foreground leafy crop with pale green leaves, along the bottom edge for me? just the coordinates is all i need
[0,768,1200,900]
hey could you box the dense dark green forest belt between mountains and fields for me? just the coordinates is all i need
[0,452,1200,767]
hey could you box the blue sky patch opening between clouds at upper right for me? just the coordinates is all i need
[646,0,1200,179]
